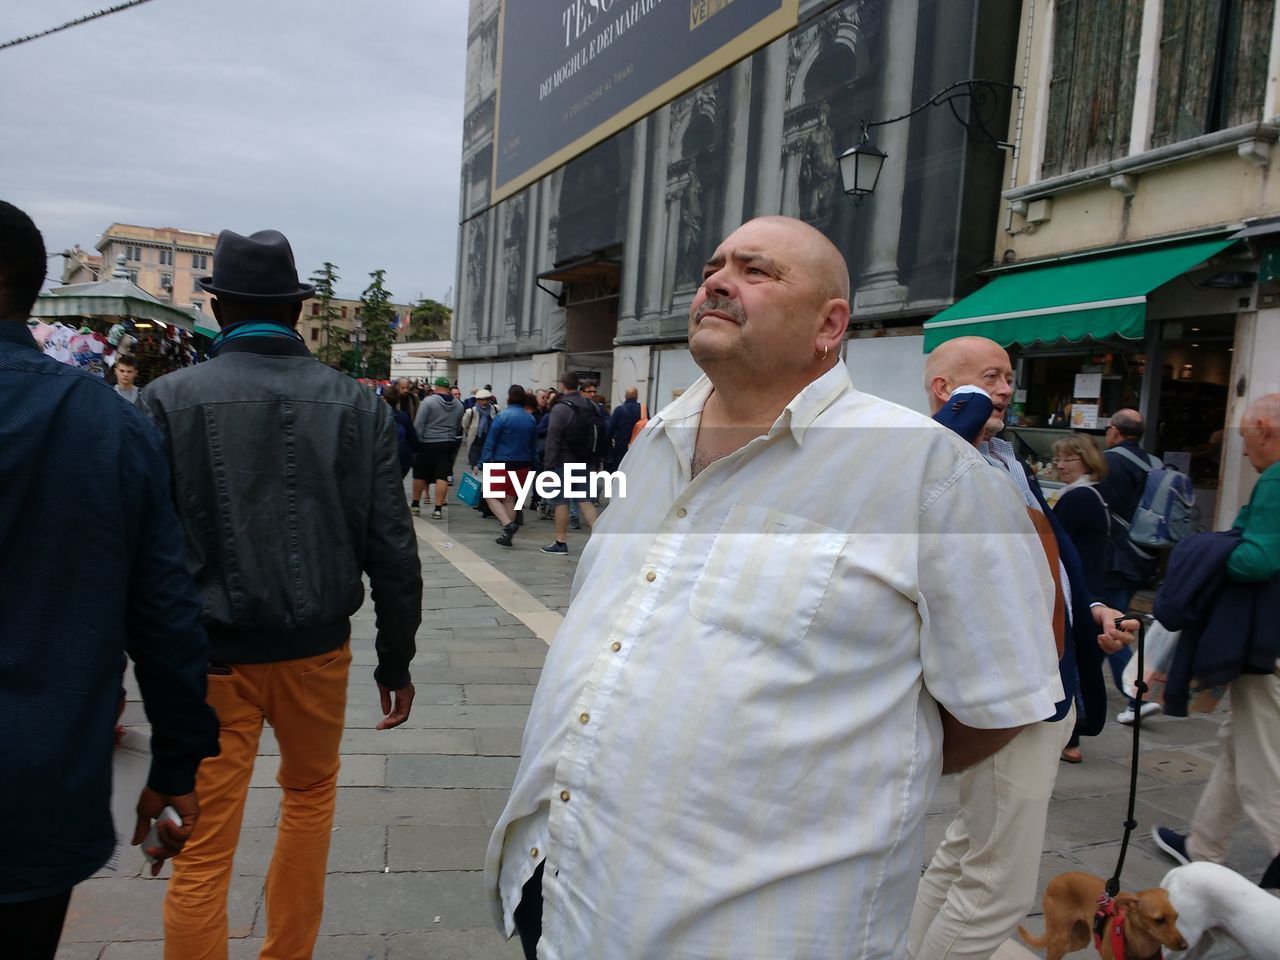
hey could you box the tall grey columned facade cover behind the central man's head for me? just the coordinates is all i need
[453,0,1018,408]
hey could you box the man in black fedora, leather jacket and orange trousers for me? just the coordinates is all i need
[140,230,422,960]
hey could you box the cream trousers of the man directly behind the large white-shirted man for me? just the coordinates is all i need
[906,708,1075,960]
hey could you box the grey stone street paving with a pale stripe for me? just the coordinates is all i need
[58,488,1270,960]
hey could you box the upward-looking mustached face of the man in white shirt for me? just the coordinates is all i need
[689,220,826,379]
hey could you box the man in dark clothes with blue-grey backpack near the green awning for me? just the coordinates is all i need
[1097,408,1194,726]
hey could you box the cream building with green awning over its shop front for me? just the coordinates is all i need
[925,0,1280,526]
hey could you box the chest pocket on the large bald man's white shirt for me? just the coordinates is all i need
[689,507,849,646]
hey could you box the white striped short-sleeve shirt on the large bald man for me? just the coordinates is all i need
[486,364,1062,960]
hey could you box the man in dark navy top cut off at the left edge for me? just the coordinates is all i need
[0,201,218,957]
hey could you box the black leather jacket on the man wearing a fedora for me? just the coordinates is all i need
[140,338,422,689]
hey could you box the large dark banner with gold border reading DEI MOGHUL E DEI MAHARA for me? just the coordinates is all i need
[492,0,800,202]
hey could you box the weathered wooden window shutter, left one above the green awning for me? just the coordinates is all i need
[1041,0,1146,177]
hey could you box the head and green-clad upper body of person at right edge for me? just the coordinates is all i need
[1226,393,1280,582]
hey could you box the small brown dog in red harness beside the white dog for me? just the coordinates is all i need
[1018,873,1187,960]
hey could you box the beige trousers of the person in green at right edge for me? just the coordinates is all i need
[1187,673,1280,864]
